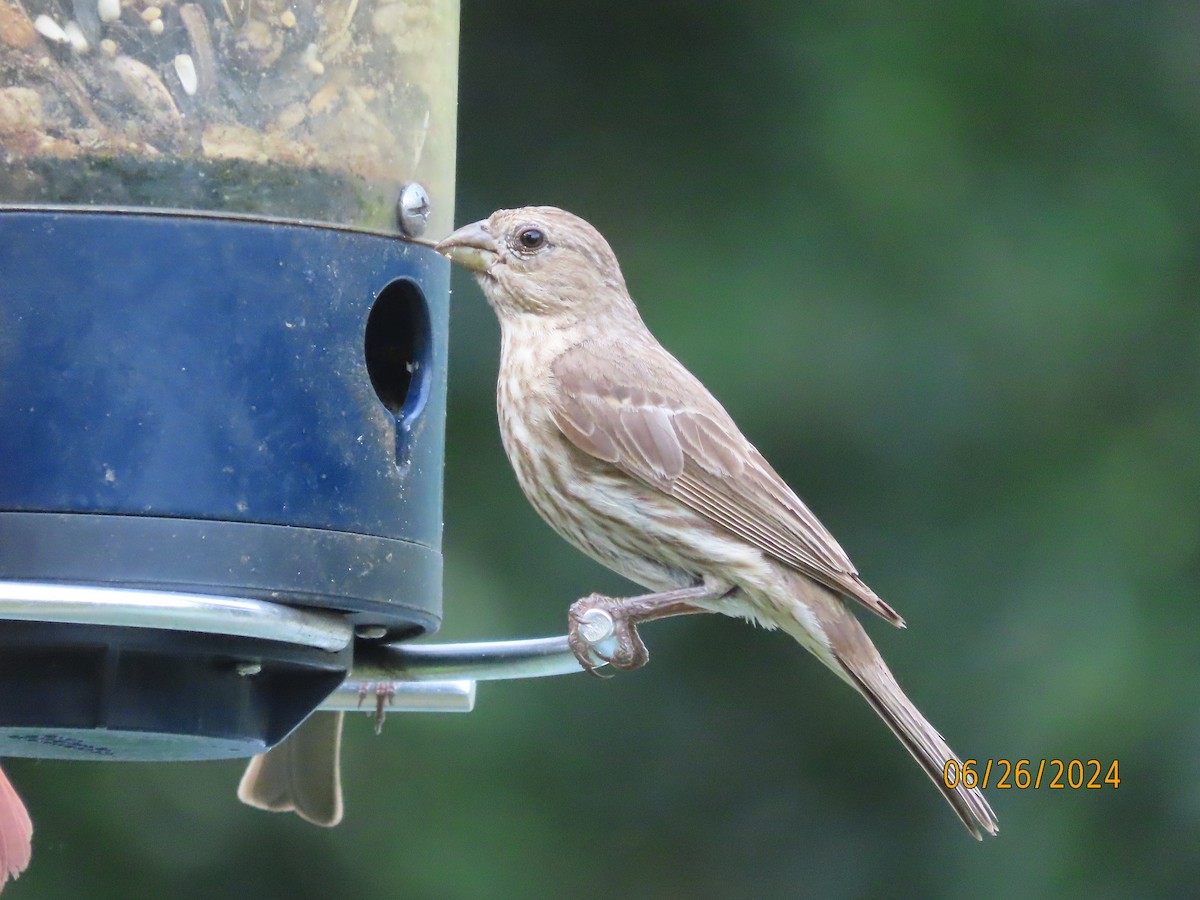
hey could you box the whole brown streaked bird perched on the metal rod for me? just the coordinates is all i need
[437,206,997,839]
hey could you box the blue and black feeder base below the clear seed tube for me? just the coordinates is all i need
[0,209,449,758]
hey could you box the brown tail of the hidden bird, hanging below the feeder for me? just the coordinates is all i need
[238,713,344,828]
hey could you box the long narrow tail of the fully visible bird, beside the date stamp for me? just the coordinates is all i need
[777,586,1000,840]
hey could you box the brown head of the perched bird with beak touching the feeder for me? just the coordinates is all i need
[437,206,632,322]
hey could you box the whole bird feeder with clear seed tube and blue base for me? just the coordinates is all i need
[0,0,462,760]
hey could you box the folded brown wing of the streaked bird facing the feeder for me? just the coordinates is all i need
[551,341,904,628]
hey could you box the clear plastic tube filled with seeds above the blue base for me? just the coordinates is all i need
[0,0,458,233]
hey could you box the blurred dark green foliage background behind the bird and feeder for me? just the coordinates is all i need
[5,0,1200,900]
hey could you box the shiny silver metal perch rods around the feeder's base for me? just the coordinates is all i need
[0,581,600,713]
